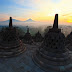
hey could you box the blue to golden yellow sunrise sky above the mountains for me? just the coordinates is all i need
[0,0,72,24]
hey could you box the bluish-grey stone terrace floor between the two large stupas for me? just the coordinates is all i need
[0,44,44,72]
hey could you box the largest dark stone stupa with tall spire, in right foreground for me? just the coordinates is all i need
[32,14,72,72]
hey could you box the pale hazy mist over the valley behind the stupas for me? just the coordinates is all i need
[0,21,72,36]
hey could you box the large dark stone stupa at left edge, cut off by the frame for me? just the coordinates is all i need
[0,17,26,57]
